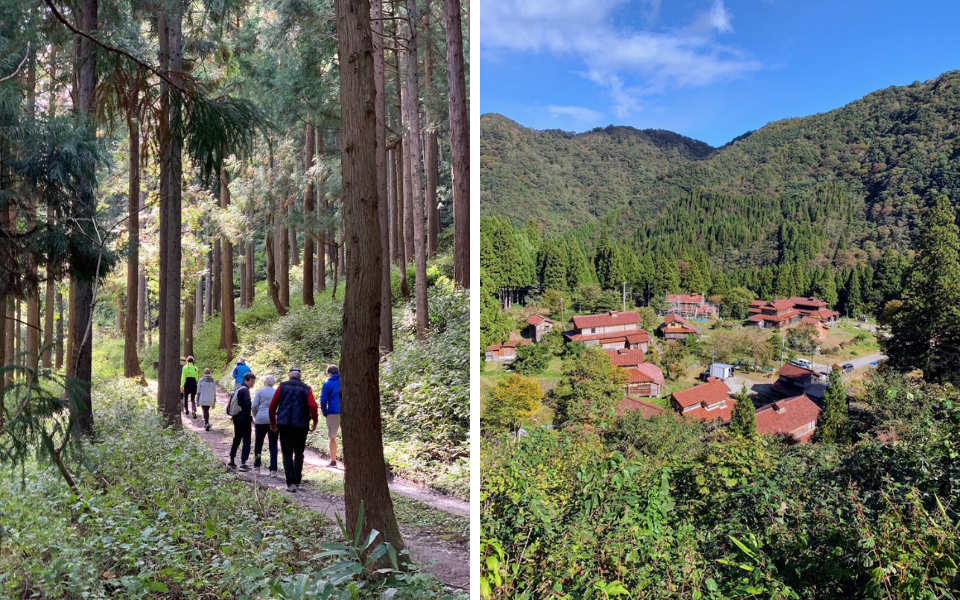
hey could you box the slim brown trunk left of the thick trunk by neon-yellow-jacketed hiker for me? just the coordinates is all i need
[123,116,143,377]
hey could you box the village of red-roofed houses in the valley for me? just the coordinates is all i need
[486,294,882,443]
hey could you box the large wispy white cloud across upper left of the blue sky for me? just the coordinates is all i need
[480,0,761,118]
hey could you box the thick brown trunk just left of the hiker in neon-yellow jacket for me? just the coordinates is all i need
[157,3,183,428]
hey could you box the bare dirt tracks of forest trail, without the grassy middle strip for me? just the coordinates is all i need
[180,389,470,591]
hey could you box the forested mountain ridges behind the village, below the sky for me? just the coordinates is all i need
[480,71,960,258]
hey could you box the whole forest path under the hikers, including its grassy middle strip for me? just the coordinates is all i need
[180,389,470,591]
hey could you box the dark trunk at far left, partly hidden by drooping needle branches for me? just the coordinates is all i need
[70,0,99,437]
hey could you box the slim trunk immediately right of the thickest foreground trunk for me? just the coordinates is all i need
[371,0,393,352]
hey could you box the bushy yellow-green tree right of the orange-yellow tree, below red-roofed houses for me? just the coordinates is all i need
[553,346,628,425]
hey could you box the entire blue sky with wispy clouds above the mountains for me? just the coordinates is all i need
[480,0,960,146]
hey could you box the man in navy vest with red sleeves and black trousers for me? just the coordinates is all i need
[270,367,319,492]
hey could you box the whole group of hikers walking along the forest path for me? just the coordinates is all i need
[180,356,340,492]
